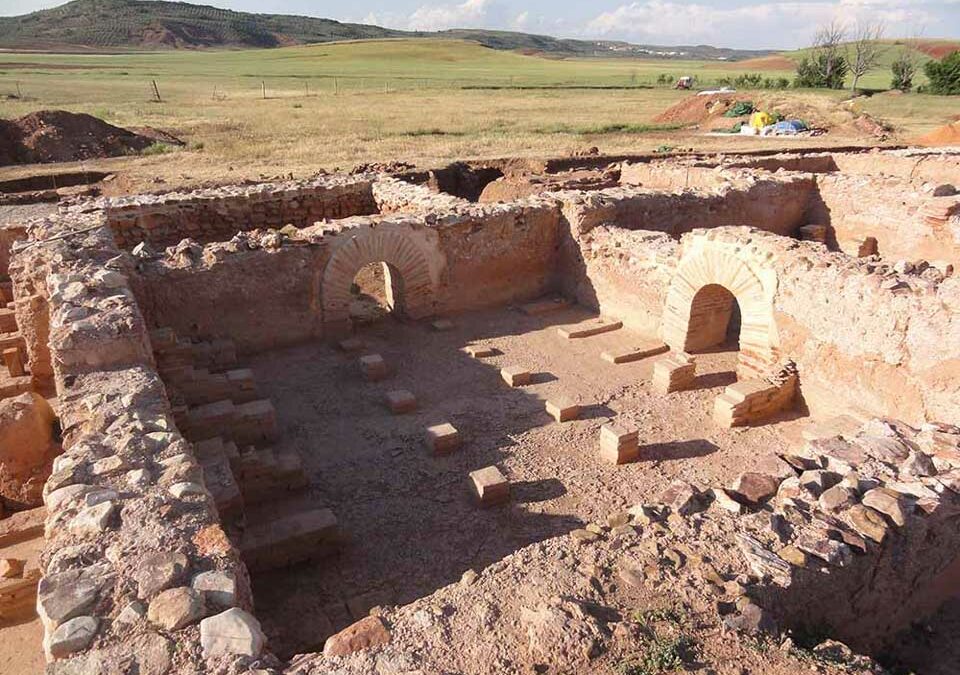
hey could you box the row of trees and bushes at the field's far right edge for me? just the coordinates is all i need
[794,22,960,94]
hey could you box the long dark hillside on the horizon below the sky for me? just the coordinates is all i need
[0,0,768,61]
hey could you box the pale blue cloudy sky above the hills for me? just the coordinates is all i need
[0,0,960,49]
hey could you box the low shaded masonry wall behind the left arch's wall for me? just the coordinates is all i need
[94,176,378,249]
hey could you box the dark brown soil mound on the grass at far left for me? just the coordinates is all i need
[0,110,183,166]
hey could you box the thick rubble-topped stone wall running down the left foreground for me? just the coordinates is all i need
[13,216,272,674]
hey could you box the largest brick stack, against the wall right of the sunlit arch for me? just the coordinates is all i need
[713,361,799,427]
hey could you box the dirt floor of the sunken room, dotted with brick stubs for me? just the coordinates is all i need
[242,309,807,655]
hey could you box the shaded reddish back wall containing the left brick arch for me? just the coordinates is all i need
[132,202,559,352]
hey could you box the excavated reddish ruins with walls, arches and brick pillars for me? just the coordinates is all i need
[0,148,960,675]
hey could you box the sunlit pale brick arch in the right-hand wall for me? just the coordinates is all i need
[662,248,777,375]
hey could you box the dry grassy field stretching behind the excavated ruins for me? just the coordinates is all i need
[0,40,956,189]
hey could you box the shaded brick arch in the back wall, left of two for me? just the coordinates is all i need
[320,228,436,324]
